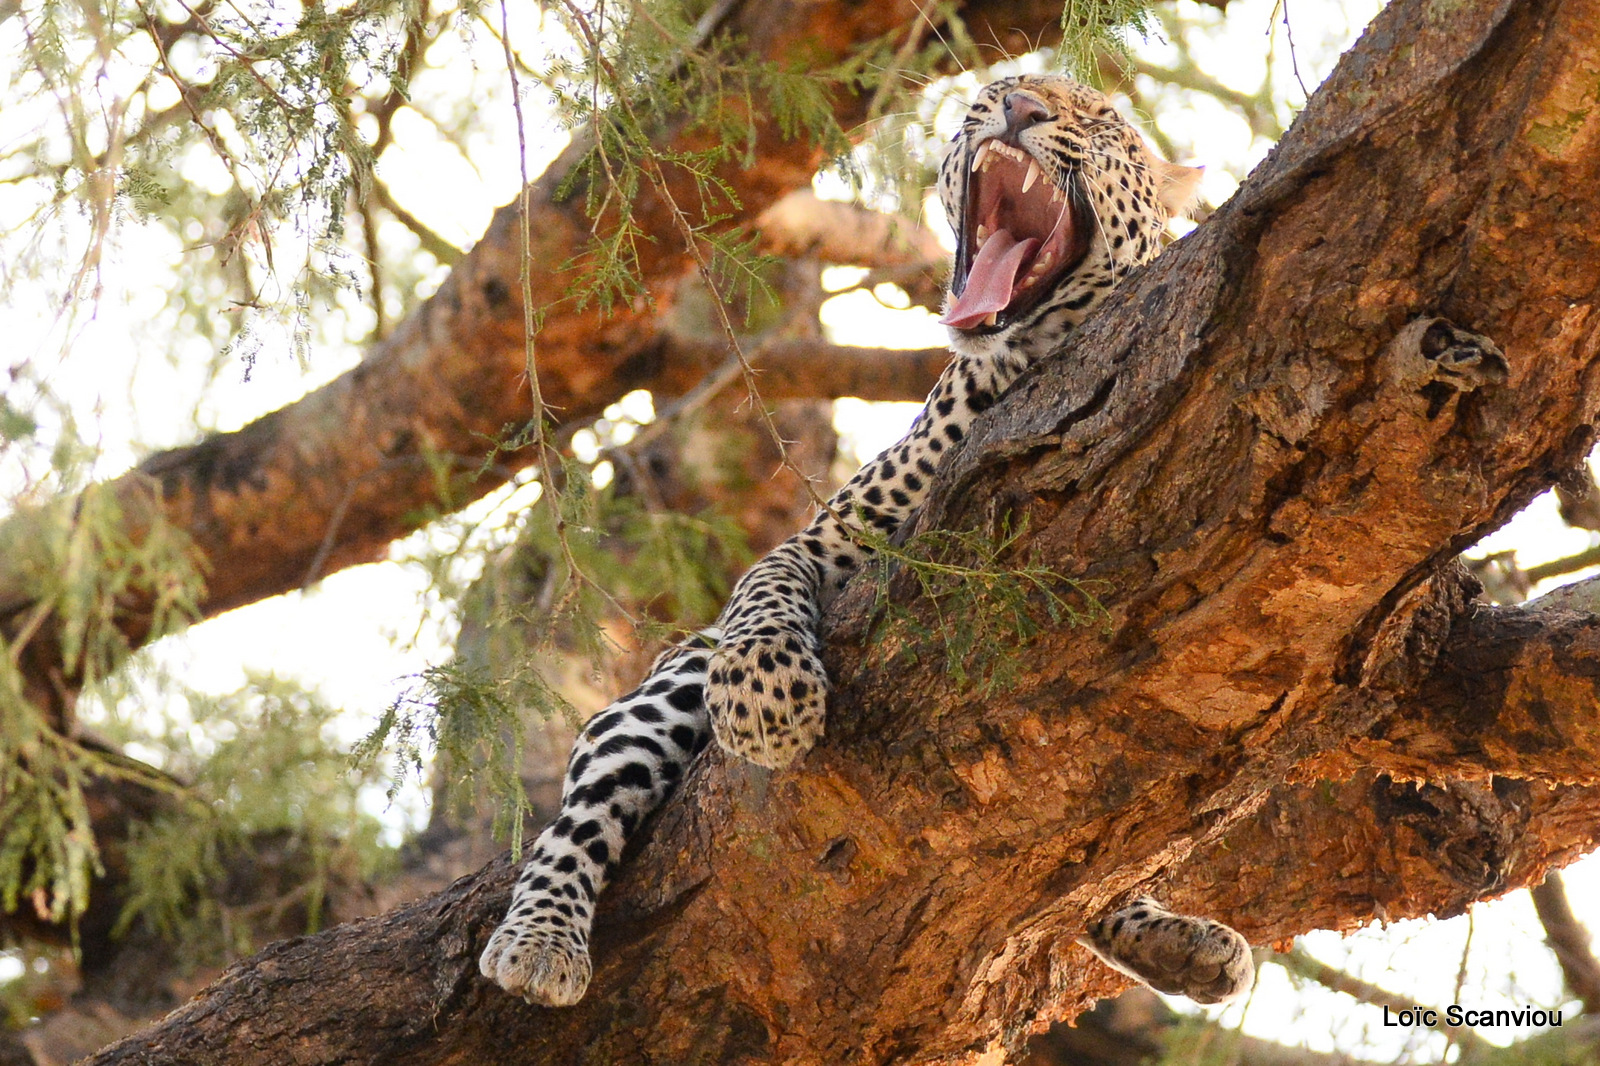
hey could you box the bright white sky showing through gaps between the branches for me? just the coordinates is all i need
[0,0,1600,1061]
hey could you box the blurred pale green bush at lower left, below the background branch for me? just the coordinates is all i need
[118,675,394,960]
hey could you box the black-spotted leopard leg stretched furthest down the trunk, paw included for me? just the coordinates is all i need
[478,651,709,1007]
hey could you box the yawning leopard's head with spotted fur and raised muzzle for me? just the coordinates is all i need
[939,74,1200,359]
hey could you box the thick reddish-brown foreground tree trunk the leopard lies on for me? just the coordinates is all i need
[78,0,1600,1064]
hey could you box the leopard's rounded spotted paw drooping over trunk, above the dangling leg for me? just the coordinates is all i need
[706,634,827,770]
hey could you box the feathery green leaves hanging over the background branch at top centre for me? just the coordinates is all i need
[538,0,853,309]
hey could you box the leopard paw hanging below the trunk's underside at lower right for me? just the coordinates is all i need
[1082,896,1256,1004]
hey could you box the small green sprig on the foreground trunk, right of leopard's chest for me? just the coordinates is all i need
[856,522,1110,698]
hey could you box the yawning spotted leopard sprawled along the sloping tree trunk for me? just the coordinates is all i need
[478,74,1254,1007]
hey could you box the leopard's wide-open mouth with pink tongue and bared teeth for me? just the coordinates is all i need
[939,138,1093,333]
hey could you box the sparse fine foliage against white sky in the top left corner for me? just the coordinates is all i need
[10,0,418,328]
